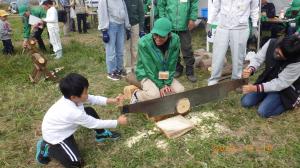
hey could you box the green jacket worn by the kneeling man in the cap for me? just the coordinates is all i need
[135,33,180,89]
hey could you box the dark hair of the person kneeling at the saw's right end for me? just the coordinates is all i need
[277,35,300,61]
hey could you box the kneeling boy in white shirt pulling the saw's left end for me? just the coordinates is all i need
[36,73,127,167]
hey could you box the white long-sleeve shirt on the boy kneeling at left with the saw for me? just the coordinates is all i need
[42,95,118,145]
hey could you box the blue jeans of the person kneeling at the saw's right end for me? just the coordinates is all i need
[241,92,286,118]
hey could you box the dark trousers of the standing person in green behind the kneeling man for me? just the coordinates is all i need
[175,30,195,75]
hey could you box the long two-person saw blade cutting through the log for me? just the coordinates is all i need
[121,79,247,117]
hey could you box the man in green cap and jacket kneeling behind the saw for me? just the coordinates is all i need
[131,18,184,103]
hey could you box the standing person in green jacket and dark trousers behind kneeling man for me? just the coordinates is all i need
[157,0,199,82]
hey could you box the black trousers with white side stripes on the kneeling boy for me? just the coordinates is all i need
[48,107,103,168]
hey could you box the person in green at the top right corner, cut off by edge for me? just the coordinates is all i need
[285,0,300,35]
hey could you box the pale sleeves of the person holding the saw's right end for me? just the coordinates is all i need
[249,40,300,92]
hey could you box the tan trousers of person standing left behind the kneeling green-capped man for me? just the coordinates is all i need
[124,24,139,72]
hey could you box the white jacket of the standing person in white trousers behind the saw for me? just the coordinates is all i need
[208,0,259,29]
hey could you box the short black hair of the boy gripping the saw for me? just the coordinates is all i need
[59,73,89,99]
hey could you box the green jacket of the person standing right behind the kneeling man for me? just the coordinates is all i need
[157,0,199,31]
